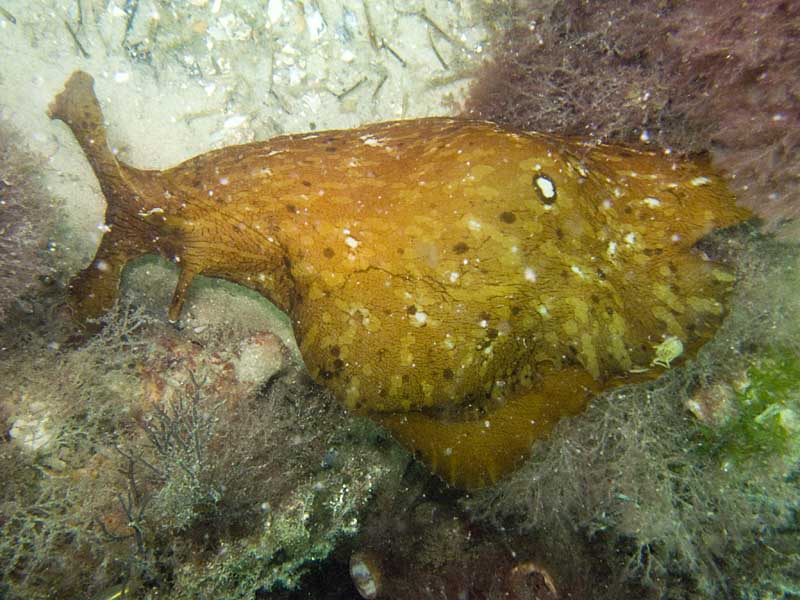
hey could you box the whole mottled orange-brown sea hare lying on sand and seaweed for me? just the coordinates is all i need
[50,72,748,488]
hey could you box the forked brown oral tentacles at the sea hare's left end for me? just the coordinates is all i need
[48,71,159,320]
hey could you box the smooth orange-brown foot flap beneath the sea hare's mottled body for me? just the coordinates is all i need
[373,367,601,490]
